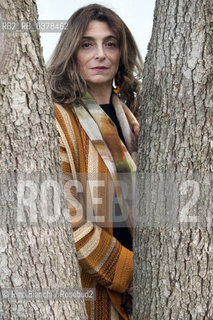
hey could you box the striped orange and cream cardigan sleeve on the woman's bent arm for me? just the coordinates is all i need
[54,104,133,293]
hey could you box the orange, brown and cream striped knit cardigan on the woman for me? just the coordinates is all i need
[55,97,136,320]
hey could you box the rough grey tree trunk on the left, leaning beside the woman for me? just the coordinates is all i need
[0,0,87,320]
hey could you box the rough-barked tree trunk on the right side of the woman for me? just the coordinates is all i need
[134,0,213,320]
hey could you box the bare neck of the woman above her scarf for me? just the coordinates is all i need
[88,85,112,104]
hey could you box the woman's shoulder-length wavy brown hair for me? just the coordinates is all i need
[48,4,143,113]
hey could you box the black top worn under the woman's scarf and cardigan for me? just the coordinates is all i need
[100,103,132,250]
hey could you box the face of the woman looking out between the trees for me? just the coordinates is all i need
[76,20,121,87]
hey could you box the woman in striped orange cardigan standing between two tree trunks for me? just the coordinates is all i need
[48,4,142,320]
